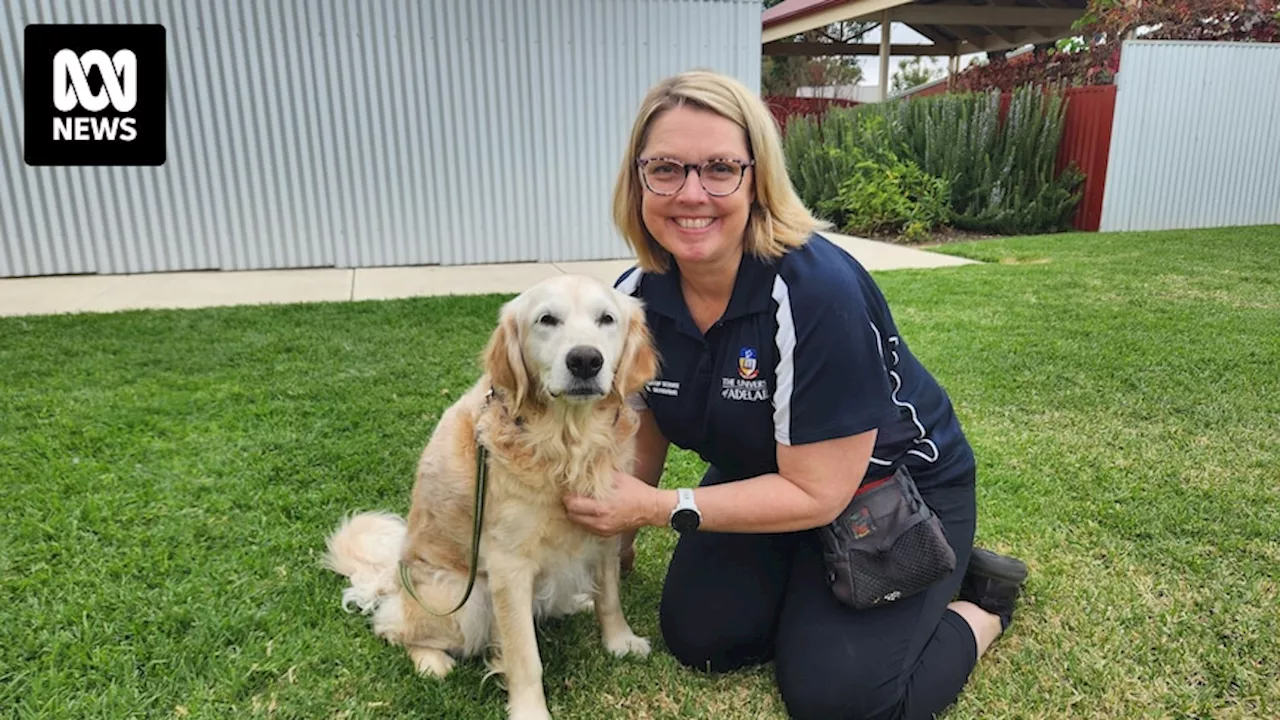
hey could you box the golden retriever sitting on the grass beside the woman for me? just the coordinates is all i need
[324,275,658,720]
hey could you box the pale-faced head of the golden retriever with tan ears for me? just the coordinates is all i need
[484,275,658,413]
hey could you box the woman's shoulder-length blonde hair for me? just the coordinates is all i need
[613,70,831,273]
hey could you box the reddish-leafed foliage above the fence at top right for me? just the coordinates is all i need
[952,0,1280,91]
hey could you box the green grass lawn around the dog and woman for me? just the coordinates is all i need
[0,227,1280,720]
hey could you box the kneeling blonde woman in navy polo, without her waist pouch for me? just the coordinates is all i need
[564,72,1025,720]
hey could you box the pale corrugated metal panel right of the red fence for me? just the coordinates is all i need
[1101,41,1280,231]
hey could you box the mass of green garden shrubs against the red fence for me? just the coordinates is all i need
[785,83,1084,234]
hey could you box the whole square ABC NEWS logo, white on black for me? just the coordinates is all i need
[24,24,166,165]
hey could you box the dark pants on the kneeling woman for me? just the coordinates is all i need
[660,468,978,720]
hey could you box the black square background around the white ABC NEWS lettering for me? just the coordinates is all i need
[23,24,168,165]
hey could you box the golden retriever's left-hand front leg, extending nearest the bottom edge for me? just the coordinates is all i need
[489,557,550,720]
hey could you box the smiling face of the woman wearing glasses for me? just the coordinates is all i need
[640,106,755,268]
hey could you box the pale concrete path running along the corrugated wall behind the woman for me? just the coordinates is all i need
[0,233,973,316]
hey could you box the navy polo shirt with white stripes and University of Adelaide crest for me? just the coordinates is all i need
[616,234,974,487]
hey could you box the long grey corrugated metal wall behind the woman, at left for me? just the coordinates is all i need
[0,0,762,277]
